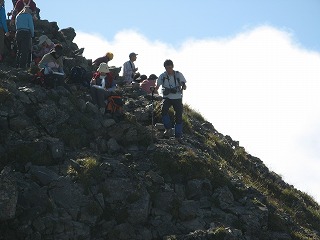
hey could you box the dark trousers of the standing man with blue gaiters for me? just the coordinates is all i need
[161,98,183,126]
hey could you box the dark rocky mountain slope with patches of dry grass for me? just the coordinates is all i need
[0,21,320,240]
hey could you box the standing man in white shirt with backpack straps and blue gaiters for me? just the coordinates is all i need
[155,60,187,139]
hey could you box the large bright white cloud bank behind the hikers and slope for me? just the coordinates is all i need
[75,26,320,202]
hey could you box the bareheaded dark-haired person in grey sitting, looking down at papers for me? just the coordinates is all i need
[38,44,71,92]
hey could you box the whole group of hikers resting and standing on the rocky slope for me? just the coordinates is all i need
[0,0,186,139]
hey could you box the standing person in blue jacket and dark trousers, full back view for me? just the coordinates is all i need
[16,7,34,68]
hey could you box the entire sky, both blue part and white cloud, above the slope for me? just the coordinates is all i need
[6,0,320,202]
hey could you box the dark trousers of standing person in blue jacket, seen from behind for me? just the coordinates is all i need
[16,30,31,68]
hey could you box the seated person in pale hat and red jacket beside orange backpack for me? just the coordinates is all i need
[90,63,116,114]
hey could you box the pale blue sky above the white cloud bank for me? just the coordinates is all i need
[6,0,320,51]
